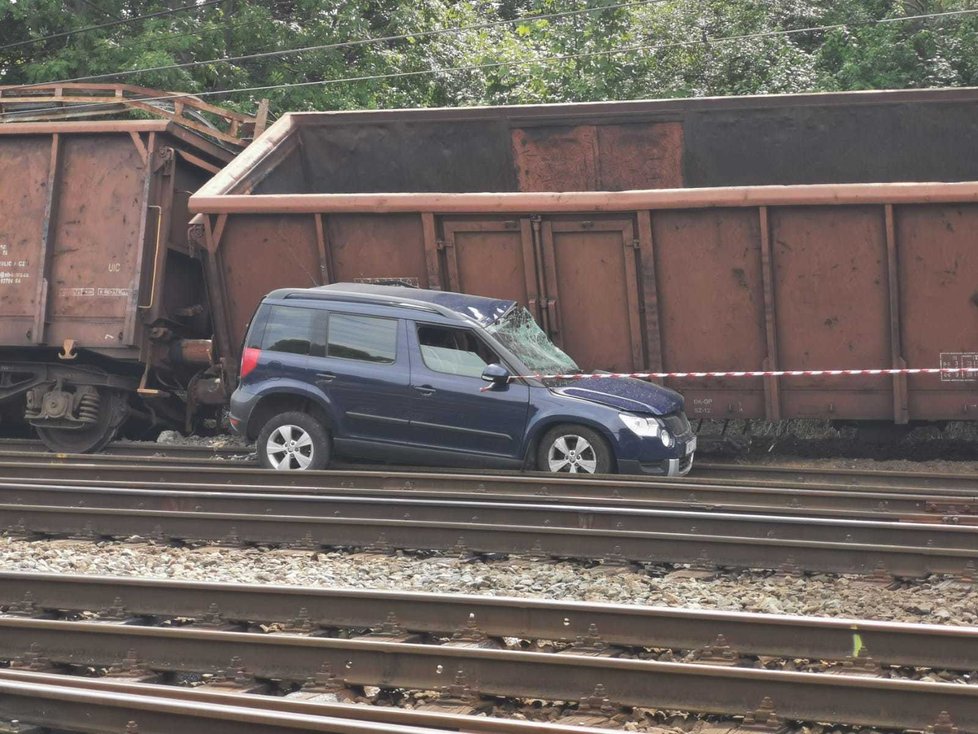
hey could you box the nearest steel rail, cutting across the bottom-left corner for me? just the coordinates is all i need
[0,677,476,734]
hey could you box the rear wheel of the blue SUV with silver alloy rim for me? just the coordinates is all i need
[257,411,330,471]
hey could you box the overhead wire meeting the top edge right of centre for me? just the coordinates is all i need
[7,0,667,89]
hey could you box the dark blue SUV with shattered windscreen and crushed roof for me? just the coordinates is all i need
[231,283,696,476]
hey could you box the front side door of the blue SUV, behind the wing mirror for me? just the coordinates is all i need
[407,322,530,458]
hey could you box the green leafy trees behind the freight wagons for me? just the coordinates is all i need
[0,0,978,112]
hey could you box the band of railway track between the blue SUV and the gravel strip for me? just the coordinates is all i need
[0,452,978,578]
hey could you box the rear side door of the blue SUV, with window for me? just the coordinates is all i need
[309,312,414,443]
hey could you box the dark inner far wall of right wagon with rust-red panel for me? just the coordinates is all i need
[198,89,978,198]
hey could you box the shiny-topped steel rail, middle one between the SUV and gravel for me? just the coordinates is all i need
[0,483,978,550]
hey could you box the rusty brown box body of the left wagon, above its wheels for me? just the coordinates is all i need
[0,121,231,366]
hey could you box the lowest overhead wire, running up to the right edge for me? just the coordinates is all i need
[0,9,978,119]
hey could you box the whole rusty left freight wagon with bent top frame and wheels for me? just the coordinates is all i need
[0,85,254,451]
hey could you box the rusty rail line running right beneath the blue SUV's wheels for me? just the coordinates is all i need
[0,453,978,522]
